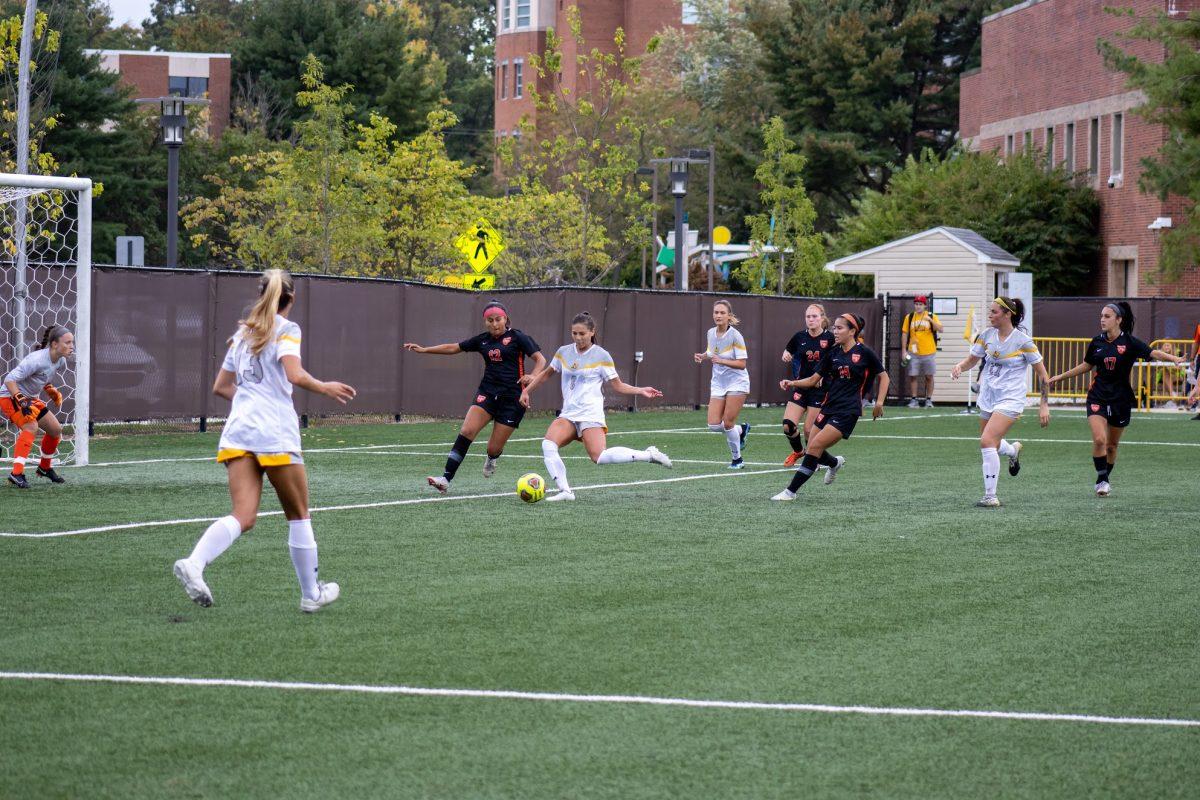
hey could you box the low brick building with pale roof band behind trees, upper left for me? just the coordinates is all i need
[86,50,230,138]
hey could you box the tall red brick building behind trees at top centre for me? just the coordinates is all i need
[496,0,694,139]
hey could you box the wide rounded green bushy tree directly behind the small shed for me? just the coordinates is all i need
[833,150,1100,295]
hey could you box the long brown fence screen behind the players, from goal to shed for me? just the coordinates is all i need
[92,267,882,422]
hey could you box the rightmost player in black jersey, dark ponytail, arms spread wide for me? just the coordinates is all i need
[1050,300,1188,498]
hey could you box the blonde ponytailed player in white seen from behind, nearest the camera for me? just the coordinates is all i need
[174,270,355,613]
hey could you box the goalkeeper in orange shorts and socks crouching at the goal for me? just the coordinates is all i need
[0,325,74,489]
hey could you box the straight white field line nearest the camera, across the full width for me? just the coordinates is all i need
[0,672,1200,728]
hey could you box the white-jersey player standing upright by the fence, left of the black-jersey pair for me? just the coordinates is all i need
[694,300,750,469]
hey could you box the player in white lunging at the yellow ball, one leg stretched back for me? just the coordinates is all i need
[521,311,671,501]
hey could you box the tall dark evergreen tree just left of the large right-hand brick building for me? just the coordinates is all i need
[748,0,1003,227]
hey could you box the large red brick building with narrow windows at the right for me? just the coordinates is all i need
[960,0,1200,296]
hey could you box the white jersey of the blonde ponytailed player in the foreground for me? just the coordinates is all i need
[220,314,300,453]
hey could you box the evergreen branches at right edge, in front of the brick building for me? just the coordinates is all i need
[1100,10,1200,282]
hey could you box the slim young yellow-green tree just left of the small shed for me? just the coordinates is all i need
[734,116,833,296]
